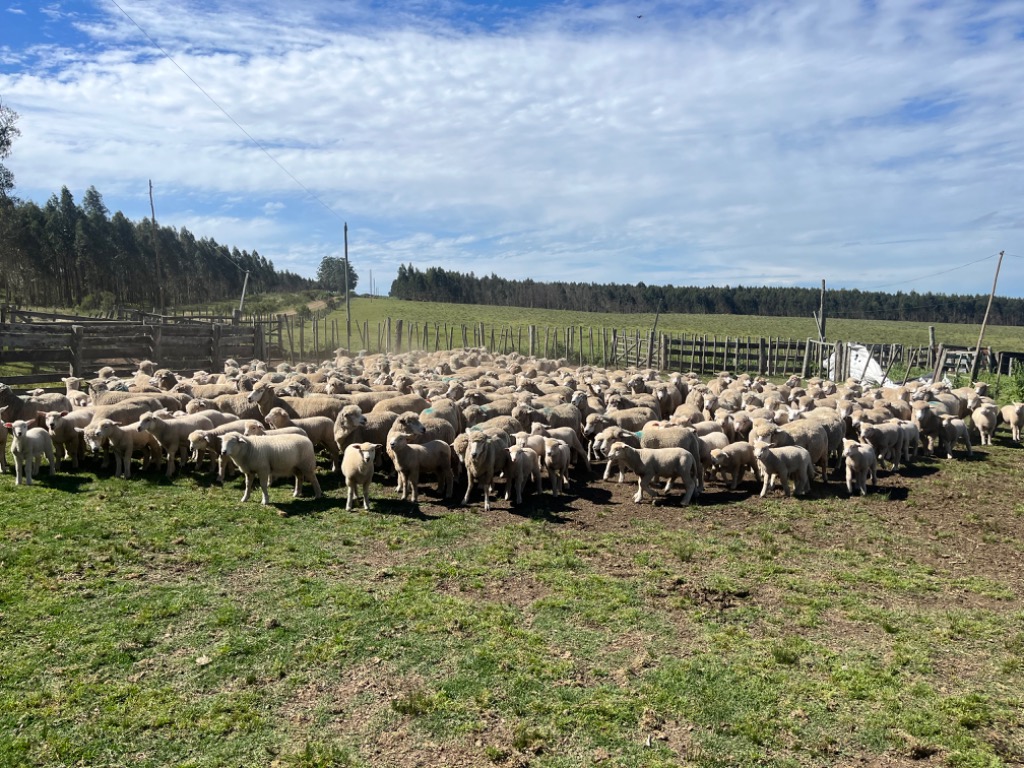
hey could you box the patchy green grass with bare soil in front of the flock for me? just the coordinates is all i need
[0,433,1024,768]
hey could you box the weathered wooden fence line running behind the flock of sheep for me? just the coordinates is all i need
[0,307,1024,385]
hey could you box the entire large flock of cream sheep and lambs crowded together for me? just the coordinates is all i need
[0,349,1024,510]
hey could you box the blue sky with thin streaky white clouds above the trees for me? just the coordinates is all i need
[0,0,1024,297]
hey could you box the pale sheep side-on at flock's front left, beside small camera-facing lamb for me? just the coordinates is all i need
[220,432,321,506]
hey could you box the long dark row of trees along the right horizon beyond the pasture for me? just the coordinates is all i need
[391,264,1024,326]
